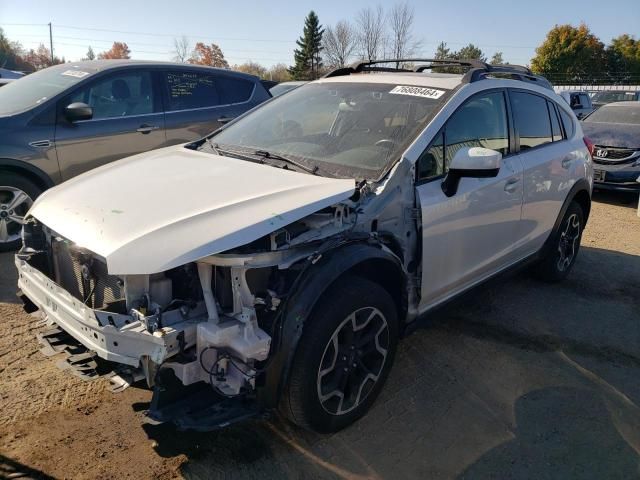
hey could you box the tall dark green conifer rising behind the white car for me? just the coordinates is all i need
[289,10,324,80]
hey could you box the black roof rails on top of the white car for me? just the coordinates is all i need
[323,58,553,89]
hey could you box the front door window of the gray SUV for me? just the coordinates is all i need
[68,71,153,120]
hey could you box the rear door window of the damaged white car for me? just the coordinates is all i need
[510,92,552,150]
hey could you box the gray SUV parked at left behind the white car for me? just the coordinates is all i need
[0,60,271,251]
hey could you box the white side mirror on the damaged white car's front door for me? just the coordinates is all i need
[442,147,502,197]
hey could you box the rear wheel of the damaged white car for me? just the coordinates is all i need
[534,202,584,283]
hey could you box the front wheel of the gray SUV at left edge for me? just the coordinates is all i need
[0,172,41,252]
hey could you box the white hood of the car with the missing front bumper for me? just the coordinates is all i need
[30,146,355,274]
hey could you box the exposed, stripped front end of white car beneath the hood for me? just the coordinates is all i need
[16,158,419,430]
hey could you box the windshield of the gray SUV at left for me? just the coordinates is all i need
[0,64,92,116]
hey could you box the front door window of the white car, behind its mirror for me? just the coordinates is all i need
[418,92,509,179]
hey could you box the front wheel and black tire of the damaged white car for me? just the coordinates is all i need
[280,275,398,433]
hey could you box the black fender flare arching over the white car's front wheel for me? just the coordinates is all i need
[256,242,406,409]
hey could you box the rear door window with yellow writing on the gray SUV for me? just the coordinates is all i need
[166,71,221,111]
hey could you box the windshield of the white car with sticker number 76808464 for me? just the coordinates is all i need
[205,82,446,179]
